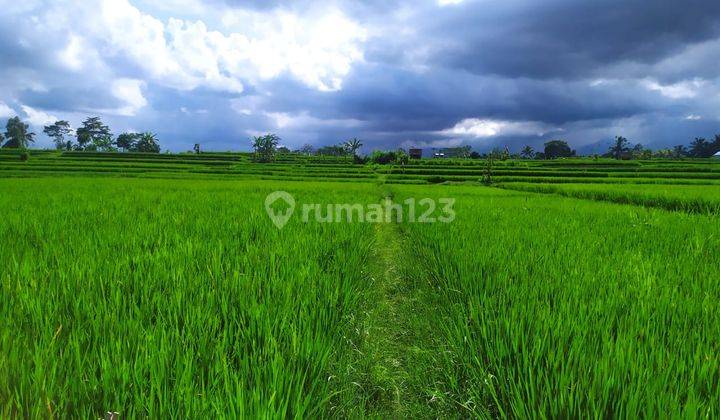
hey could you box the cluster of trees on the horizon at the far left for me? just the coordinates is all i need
[0,117,160,153]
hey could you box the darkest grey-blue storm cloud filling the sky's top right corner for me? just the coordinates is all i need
[382,0,720,78]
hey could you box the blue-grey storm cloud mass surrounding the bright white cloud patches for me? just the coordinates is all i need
[0,0,720,150]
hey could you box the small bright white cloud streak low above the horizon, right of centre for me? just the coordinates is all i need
[440,118,558,138]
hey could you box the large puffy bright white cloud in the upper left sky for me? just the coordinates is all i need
[44,0,366,93]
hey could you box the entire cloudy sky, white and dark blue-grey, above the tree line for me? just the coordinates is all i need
[0,0,720,152]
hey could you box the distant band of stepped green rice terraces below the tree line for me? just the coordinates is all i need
[0,151,720,185]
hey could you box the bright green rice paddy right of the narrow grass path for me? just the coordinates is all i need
[399,187,720,418]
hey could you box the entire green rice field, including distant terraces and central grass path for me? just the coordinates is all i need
[0,151,720,418]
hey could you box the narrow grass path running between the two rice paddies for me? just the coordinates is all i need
[340,194,452,418]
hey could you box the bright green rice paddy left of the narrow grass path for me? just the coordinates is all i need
[0,179,376,418]
